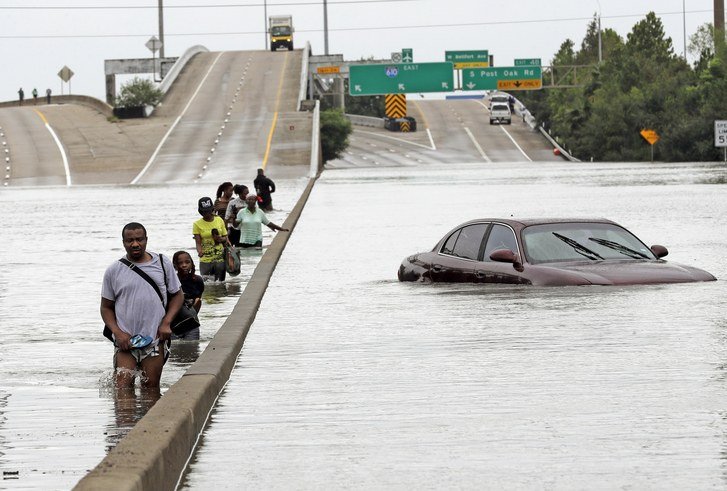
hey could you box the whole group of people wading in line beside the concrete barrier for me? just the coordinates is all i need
[100,169,288,388]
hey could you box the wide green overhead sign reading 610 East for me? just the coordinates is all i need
[348,62,454,95]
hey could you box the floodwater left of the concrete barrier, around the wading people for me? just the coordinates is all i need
[0,179,308,490]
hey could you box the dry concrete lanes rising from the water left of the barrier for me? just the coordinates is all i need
[0,50,312,186]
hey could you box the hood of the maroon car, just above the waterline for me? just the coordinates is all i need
[551,260,717,285]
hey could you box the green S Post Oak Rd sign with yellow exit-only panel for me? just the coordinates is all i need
[462,66,543,90]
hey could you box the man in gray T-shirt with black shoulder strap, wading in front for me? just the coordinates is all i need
[101,222,184,388]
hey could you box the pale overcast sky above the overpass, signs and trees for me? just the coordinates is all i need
[0,0,713,101]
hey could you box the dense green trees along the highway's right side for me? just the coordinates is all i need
[518,12,727,162]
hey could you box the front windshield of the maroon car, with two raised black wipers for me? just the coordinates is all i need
[522,222,656,264]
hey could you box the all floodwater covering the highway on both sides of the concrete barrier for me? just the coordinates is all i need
[0,162,727,489]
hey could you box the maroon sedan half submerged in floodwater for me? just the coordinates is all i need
[399,219,716,286]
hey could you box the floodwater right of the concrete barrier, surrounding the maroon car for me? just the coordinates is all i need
[182,163,727,490]
